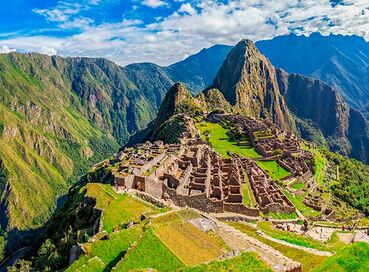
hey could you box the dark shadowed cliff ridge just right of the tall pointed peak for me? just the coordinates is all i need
[277,69,369,163]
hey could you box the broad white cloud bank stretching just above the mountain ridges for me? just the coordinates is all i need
[0,0,369,65]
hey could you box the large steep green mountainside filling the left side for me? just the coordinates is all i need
[0,53,171,253]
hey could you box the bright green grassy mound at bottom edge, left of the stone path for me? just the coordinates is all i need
[177,252,272,272]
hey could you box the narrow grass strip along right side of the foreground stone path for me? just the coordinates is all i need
[228,222,327,272]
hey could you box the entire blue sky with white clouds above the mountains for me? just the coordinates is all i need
[0,0,369,65]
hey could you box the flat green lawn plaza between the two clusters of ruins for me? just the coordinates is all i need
[196,123,262,159]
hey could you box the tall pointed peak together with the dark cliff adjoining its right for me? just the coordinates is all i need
[207,40,369,163]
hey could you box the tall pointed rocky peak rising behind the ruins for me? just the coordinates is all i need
[213,40,293,129]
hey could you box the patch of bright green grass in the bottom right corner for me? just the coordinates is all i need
[314,243,369,272]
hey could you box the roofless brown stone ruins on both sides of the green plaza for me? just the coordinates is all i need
[114,113,312,219]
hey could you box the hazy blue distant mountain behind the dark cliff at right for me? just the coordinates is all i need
[256,33,369,111]
